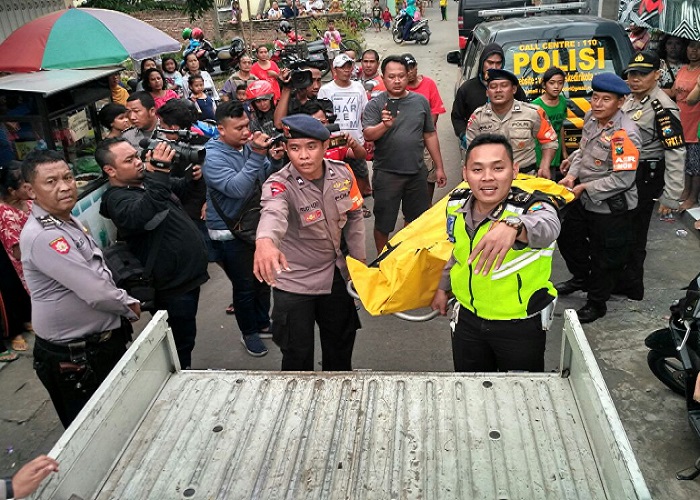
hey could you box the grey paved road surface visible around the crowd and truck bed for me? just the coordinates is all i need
[0,2,700,499]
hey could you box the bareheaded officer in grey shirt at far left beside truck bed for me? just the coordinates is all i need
[20,151,141,427]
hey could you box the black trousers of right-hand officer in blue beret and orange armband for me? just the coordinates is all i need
[557,200,634,307]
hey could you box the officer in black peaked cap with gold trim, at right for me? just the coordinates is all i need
[613,52,685,300]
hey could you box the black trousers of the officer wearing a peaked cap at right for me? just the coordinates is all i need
[614,160,665,298]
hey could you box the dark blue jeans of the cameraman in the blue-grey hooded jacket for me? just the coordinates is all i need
[211,239,270,335]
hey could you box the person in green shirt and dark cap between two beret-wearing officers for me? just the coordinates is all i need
[532,66,569,181]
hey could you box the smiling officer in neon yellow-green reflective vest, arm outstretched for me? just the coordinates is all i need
[431,134,561,372]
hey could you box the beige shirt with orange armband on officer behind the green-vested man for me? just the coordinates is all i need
[467,100,559,173]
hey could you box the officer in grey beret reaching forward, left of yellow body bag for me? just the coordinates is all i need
[254,114,366,371]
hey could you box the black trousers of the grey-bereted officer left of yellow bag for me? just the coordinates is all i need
[272,268,361,371]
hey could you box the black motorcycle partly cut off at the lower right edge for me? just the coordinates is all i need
[644,274,700,480]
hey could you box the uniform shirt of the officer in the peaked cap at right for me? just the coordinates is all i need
[622,86,686,209]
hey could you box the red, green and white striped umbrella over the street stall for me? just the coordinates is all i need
[0,9,180,73]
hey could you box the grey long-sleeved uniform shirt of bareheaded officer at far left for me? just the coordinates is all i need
[19,203,138,343]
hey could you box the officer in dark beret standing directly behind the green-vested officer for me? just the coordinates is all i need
[467,68,559,179]
